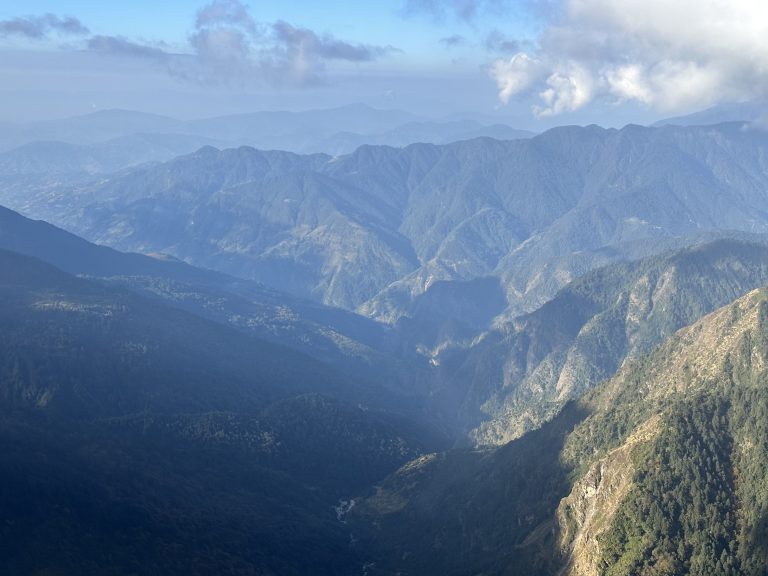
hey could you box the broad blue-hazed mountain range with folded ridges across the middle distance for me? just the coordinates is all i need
[9,123,768,348]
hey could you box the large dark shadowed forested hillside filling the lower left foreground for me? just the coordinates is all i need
[0,250,441,575]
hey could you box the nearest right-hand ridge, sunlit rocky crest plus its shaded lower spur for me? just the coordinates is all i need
[348,289,768,575]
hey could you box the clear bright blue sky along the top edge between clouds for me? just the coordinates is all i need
[0,0,536,56]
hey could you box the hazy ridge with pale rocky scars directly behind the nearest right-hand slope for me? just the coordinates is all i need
[438,240,768,444]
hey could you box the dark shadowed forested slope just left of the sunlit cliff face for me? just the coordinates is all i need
[350,404,586,575]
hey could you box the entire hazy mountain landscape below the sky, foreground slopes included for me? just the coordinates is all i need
[0,97,768,576]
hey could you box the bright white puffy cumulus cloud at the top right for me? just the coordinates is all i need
[488,0,768,116]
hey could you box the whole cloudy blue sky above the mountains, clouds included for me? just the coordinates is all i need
[0,0,768,129]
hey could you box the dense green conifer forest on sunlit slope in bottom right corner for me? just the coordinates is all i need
[601,382,768,576]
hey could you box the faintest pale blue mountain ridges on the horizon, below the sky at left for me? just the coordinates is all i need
[0,104,533,168]
